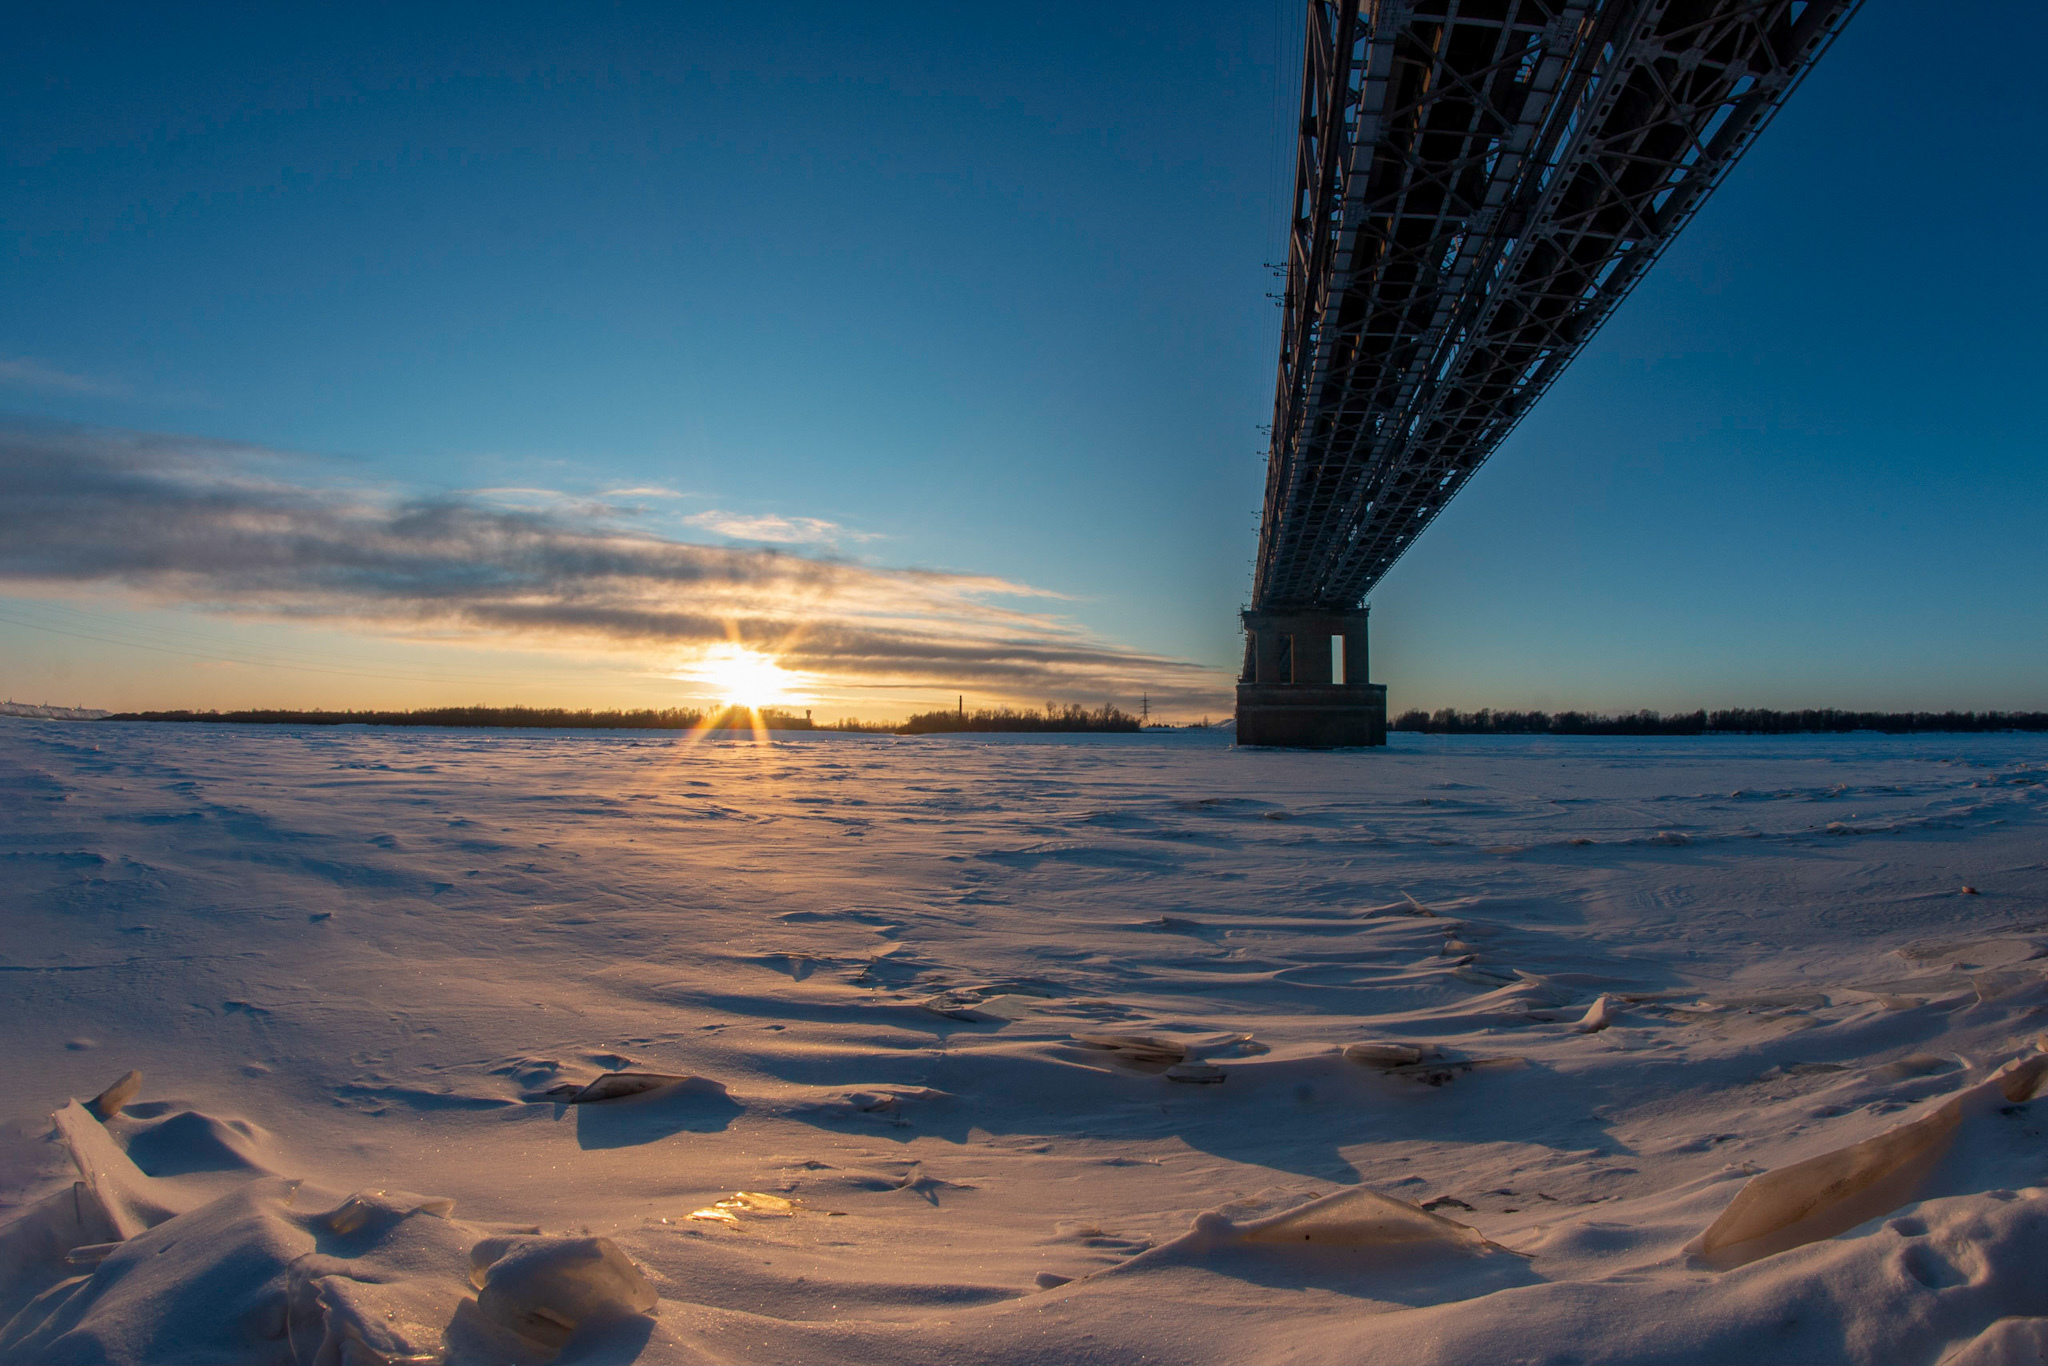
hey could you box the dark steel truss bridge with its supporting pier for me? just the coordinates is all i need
[1237,0,1860,748]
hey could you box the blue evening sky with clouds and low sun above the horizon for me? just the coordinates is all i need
[0,0,2048,719]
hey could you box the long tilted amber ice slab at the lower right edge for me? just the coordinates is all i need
[1686,1053,2048,1270]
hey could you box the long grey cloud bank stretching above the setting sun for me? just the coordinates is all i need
[0,426,1227,709]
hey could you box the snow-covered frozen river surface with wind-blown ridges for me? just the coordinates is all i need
[0,721,2048,1366]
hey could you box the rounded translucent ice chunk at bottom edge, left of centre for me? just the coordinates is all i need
[469,1237,657,1348]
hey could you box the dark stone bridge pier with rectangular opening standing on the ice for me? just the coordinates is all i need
[1237,608,1386,750]
